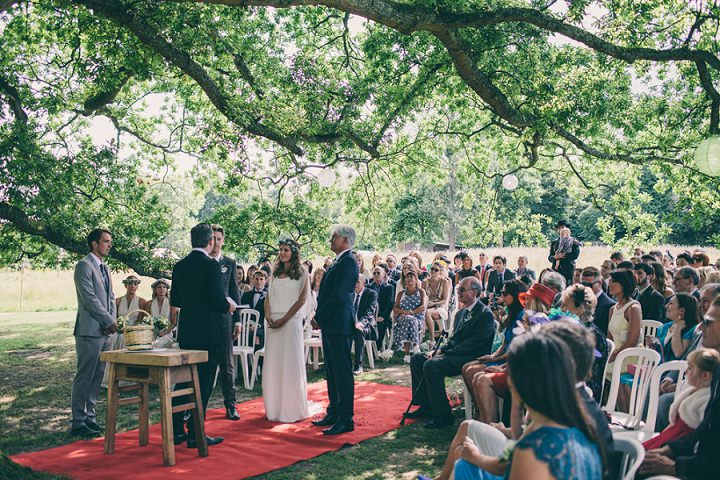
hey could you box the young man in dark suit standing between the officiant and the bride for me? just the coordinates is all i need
[210,225,240,420]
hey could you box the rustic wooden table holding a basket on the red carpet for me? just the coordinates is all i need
[100,349,208,466]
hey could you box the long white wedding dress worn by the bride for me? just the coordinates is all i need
[262,276,310,423]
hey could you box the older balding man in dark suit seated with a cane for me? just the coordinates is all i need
[407,277,495,428]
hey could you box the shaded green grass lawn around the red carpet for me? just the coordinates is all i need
[0,311,462,480]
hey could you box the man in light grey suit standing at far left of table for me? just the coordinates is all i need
[70,228,117,437]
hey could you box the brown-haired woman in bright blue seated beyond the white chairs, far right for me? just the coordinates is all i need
[645,293,700,362]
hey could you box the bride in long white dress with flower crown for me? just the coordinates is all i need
[262,239,310,423]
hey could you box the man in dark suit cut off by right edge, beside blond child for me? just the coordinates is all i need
[640,298,720,479]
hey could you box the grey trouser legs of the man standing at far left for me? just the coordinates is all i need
[70,336,104,428]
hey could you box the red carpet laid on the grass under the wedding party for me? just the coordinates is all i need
[11,382,410,480]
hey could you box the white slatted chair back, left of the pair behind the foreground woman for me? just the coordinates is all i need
[605,347,660,430]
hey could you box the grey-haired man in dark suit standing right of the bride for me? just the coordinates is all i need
[312,225,360,435]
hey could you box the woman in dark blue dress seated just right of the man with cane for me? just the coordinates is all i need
[462,280,527,405]
